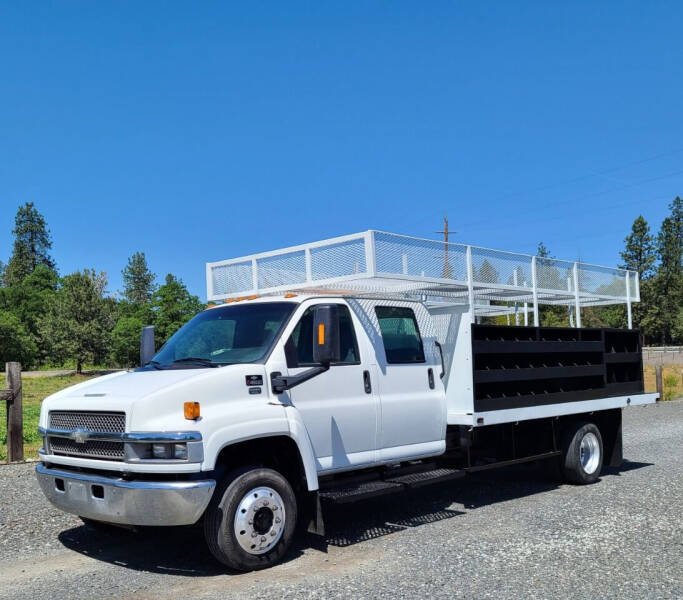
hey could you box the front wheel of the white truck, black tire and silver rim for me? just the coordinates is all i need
[204,467,297,571]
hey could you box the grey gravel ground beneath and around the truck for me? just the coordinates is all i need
[0,401,683,600]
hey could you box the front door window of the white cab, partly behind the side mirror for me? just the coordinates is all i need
[285,304,360,368]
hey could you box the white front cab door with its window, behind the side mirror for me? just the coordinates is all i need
[285,300,379,472]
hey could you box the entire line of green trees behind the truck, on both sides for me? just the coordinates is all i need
[0,197,683,371]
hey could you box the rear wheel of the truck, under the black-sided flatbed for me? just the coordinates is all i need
[562,423,603,485]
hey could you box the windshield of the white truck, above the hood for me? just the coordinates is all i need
[150,302,296,368]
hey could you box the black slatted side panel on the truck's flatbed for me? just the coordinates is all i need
[472,325,643,412]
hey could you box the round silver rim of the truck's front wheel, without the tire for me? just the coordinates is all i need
[234,487,286,554]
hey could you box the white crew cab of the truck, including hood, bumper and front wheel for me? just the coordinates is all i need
[38,294,446,568]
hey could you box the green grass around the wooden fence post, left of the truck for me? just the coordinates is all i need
[0,375,96,462]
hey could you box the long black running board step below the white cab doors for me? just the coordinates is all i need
[320,467,465,504]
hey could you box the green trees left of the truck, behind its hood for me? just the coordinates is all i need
[0,202,204,372]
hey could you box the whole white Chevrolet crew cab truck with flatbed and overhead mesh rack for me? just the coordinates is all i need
[37,231,656,570]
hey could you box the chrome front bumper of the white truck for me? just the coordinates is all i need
[36,463,216,525]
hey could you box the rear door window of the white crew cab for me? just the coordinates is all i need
[375,306,425,364]
